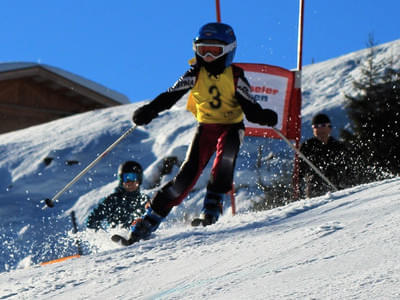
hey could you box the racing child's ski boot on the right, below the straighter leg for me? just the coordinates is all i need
[192,191,224,226]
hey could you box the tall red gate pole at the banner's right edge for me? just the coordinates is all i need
[293,0,304,200]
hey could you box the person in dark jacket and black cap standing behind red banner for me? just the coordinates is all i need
[299,113,351,197]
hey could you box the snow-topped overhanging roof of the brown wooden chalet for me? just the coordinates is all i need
[0,62,130,106]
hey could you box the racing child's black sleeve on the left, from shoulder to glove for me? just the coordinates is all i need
[148,67,198,113]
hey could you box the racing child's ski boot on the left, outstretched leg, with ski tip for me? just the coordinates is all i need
[111,207,164,246]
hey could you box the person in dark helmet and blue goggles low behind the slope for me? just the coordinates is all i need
[86,161,149,230]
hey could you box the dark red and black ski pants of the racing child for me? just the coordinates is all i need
[151,122,244,217]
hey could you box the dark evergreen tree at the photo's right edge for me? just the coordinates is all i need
[341,36,400,183]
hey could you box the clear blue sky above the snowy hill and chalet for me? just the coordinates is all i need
[0,0,400,102]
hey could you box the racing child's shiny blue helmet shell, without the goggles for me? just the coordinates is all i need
[193,23,236,67]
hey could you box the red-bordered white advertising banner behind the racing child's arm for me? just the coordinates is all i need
[235,63,301,140]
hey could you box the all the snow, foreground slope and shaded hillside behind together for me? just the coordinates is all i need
[0,41,400,299]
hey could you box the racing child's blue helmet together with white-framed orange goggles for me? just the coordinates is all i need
[193,23,236,67]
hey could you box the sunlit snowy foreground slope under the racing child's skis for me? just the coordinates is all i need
[0,178,400,300]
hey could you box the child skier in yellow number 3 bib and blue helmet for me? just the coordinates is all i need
[113,23,277,245]
